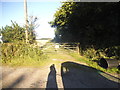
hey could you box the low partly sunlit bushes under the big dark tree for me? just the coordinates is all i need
[80,46,120,60]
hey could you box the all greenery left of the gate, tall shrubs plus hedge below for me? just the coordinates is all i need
[0,16,42,66]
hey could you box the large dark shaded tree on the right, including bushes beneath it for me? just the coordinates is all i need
[50,2,120,58]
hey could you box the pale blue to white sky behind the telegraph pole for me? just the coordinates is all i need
[0,0,61,39]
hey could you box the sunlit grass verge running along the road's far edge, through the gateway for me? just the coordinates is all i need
[3,42,120,73]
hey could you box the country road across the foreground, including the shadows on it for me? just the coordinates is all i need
[2,61,119,88]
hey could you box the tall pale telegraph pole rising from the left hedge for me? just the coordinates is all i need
[24,0,28,43]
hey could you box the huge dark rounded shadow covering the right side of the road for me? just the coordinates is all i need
[61,62,120,88]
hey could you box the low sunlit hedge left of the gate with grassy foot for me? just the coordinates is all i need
[1,42,47,66]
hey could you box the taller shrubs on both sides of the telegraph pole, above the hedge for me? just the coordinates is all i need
[1,16,39,43]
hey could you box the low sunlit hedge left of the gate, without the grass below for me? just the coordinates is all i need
[1,42,44,63]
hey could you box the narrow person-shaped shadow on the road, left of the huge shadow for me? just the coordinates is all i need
[46,64,58,90]
